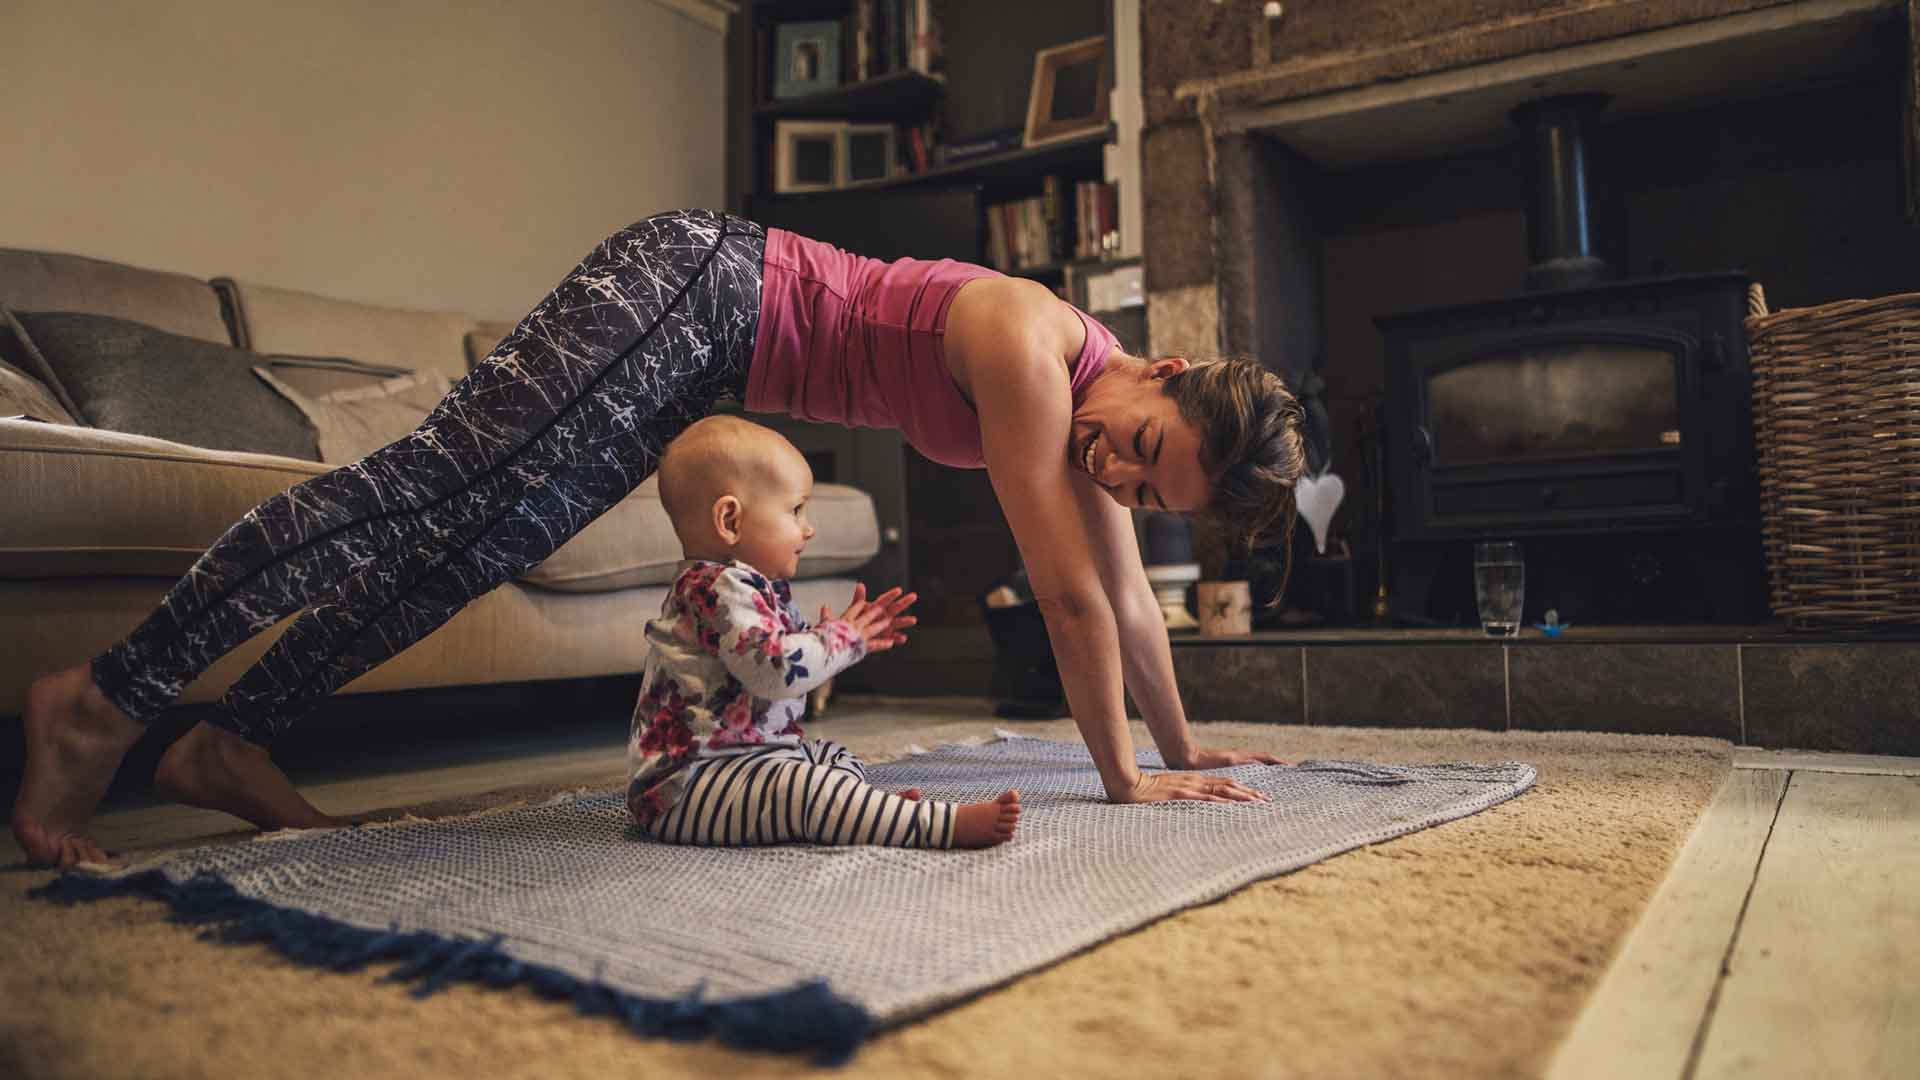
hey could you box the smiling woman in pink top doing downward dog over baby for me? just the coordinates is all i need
[13,211,1304,865]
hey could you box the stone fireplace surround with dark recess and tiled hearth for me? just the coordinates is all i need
[1140,0,1920,755]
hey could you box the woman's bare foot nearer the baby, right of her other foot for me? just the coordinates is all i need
[154,723,342,828]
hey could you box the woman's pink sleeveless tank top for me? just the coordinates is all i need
[747,229,1119,469]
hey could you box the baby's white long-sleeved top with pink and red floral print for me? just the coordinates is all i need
[626,559,866,826]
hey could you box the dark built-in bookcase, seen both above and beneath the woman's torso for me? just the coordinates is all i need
[728,0,1117,680]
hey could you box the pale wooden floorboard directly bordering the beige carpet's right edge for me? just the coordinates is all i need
[1548,769,1788,1080]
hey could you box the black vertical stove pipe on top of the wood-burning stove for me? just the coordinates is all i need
[1513,94,1613,292]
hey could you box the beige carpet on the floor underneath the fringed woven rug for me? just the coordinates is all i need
[0,709,1730,1080]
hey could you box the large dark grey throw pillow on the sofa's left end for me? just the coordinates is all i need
[8,311,321,461]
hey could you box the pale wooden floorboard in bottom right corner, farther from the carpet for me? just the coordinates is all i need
[1697,773,1920,1080]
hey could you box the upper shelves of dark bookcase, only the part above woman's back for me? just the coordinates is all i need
[730,0,1117,267]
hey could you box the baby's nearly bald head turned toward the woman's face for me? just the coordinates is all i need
[660,415,814,578]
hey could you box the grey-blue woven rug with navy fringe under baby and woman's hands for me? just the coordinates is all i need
[56,738,1534,1045]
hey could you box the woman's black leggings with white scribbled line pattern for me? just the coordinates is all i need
[92,211,766,744]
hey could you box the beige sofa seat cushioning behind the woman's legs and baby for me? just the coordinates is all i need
[0,421,879,592]
